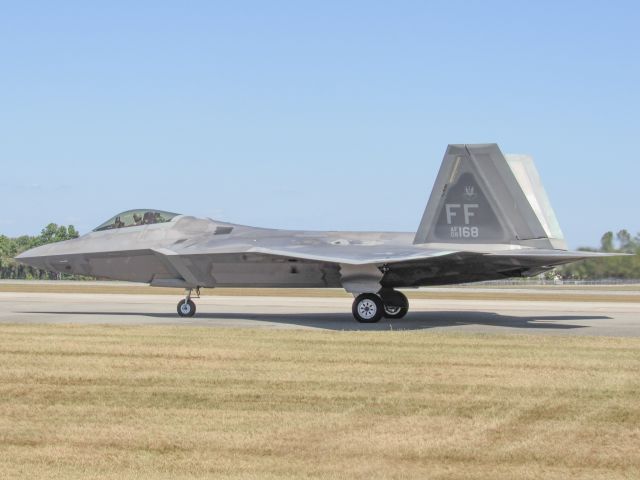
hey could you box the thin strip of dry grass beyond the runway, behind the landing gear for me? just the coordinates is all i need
[0,281,640,303]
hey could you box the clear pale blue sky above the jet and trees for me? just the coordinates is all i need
[0,1,640,247]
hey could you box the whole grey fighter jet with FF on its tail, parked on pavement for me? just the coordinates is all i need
[16,144,606,323]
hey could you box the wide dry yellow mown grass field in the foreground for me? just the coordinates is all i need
[0,325,640,479]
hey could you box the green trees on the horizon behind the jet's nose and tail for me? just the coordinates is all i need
[0,223,640,280]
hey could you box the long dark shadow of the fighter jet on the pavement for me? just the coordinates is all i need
[24,311,611,331]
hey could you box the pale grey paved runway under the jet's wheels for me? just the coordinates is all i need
[0,292,640,337]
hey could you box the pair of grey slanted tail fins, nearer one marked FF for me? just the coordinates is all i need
[414,143,566,250]
